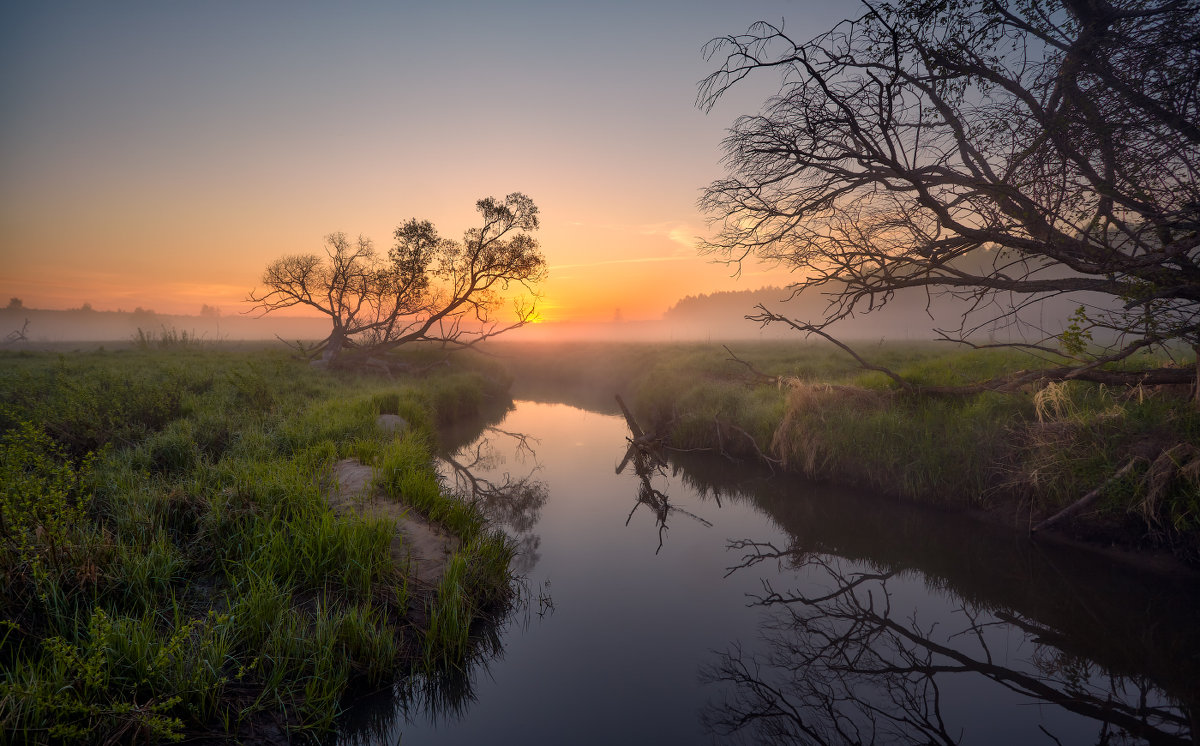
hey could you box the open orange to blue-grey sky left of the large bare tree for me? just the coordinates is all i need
[0,0,859,320]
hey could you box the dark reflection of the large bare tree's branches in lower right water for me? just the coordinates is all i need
[704,549,1193,744]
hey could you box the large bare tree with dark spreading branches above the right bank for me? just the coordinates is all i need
[698,0,1200,395]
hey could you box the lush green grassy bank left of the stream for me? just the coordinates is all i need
[0,341,512,744]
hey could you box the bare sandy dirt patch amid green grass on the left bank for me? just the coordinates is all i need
[325,458,460,588]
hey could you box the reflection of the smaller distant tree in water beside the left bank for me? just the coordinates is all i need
[442,426,550,574]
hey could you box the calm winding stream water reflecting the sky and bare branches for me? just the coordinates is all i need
[342,402,1200,745]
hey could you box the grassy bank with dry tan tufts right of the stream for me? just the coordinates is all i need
[496,343,1200,562]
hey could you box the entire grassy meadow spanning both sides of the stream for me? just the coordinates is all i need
[0,333,1200,744]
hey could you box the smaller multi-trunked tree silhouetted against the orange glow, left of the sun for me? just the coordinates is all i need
[247,192,546,365]
